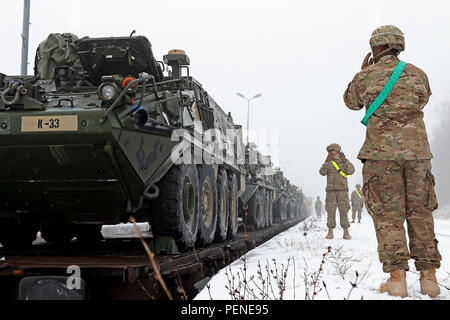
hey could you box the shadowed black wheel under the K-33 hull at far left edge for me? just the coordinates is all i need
[0,219,39,249]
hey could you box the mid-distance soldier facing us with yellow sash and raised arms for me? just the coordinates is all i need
[319,143,355,240]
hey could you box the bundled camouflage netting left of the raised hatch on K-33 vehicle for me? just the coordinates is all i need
[34,33,85,79]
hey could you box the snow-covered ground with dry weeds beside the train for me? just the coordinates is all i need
[195,211,450,300]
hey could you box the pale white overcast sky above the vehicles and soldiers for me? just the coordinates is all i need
[0,0,450,202]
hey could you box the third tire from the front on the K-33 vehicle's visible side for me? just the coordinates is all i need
[214,169,230,242]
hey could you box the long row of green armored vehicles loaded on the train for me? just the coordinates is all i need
[0,34,307,249]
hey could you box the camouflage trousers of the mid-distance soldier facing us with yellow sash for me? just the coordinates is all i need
[325,190,350,229]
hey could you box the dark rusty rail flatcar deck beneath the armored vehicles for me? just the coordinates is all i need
[0,218,301,300]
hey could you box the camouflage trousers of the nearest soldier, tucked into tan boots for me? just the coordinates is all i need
[362,160,442,272]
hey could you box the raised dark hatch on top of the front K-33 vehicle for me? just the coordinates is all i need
[76,36,163,85]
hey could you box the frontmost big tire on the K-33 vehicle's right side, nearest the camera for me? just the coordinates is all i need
[150,164,199,250]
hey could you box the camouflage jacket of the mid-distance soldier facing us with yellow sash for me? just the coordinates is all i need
[319,157,355,191]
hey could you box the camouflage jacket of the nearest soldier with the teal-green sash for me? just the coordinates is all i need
[344,55,433,160]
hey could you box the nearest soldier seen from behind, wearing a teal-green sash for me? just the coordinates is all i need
[344,26,441,297]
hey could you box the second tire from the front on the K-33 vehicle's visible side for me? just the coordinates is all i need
[196,165,217,247]
